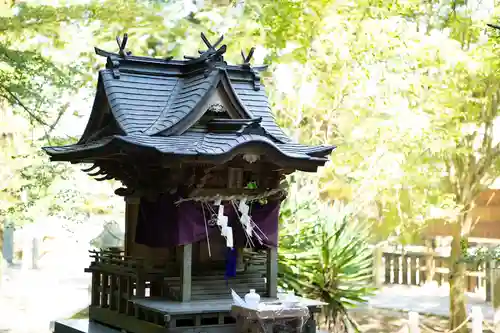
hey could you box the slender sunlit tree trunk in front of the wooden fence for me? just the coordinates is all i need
[449,221,468,333]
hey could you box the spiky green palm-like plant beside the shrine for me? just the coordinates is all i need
[279,193,374,332]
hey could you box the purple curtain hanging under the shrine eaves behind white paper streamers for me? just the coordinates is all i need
[135,194,280,248]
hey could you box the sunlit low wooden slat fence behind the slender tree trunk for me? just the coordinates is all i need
[374,250,487,292]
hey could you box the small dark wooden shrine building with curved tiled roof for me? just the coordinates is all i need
[44,34,334,333]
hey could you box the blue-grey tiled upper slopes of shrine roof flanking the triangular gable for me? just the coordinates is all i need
[100,66,290,143]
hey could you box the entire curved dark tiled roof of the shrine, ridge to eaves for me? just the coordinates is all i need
[44,36,334,169]
